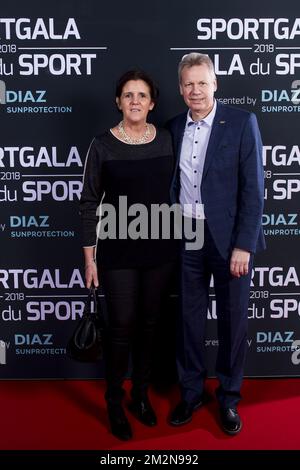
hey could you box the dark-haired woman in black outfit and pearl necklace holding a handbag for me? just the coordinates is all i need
[80,70,176,440]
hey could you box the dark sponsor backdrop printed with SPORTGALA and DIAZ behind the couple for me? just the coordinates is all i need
[0,0,300,378]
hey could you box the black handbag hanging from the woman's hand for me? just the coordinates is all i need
[66,287,104,362]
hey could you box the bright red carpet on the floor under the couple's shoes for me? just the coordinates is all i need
[0,379,300,450]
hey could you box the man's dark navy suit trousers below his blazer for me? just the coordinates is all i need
[177,220,253,408]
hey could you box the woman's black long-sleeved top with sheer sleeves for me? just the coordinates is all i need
[80,129,178,269]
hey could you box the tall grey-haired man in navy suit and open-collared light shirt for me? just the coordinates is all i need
[169,52,265,434]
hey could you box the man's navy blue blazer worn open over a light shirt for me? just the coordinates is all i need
[167,102,265,259]
